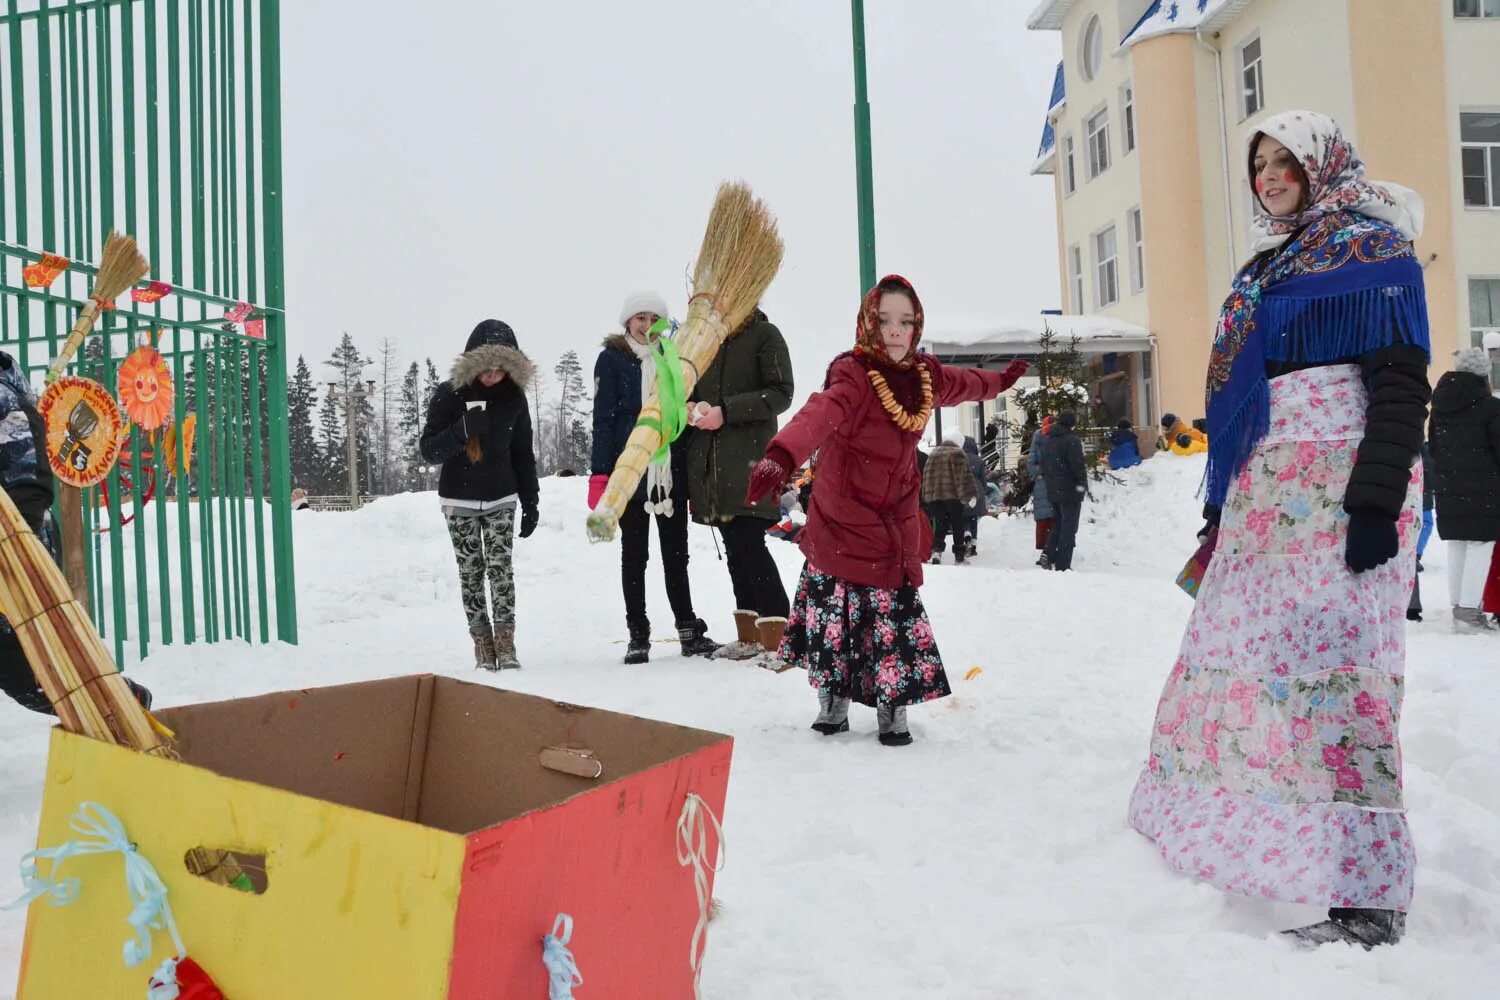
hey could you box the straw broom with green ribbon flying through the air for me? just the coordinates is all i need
[588,183,782,541]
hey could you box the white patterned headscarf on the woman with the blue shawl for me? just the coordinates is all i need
[1245,111,1424,253]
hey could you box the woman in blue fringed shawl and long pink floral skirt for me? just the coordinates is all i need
[1130,111,1431,948]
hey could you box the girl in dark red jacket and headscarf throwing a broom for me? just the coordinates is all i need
[749,274,1026,747]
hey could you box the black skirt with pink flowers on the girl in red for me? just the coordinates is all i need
[777,565,953,708]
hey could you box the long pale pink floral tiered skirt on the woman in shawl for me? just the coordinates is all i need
[1130,366,1422,910]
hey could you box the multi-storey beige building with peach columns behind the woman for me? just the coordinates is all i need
[1028,0,1500,424]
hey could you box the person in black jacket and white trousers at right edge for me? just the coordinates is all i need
[1428,348,1500,633]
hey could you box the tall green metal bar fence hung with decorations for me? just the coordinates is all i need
[0,0,297,660]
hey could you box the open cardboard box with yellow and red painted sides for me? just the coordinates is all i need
[18,676,732,1000]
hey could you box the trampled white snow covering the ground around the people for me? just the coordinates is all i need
[0,457,1500,1000]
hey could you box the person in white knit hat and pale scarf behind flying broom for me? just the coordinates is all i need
[588,292,719,664]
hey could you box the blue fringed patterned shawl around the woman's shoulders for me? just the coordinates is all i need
[1205,211,1431,507]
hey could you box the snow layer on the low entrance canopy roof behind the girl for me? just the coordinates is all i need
[923,313,1152,358]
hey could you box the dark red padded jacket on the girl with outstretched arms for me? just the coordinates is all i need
[767,354,1016,589]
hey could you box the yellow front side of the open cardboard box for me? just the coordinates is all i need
[18,730,464,1000]
